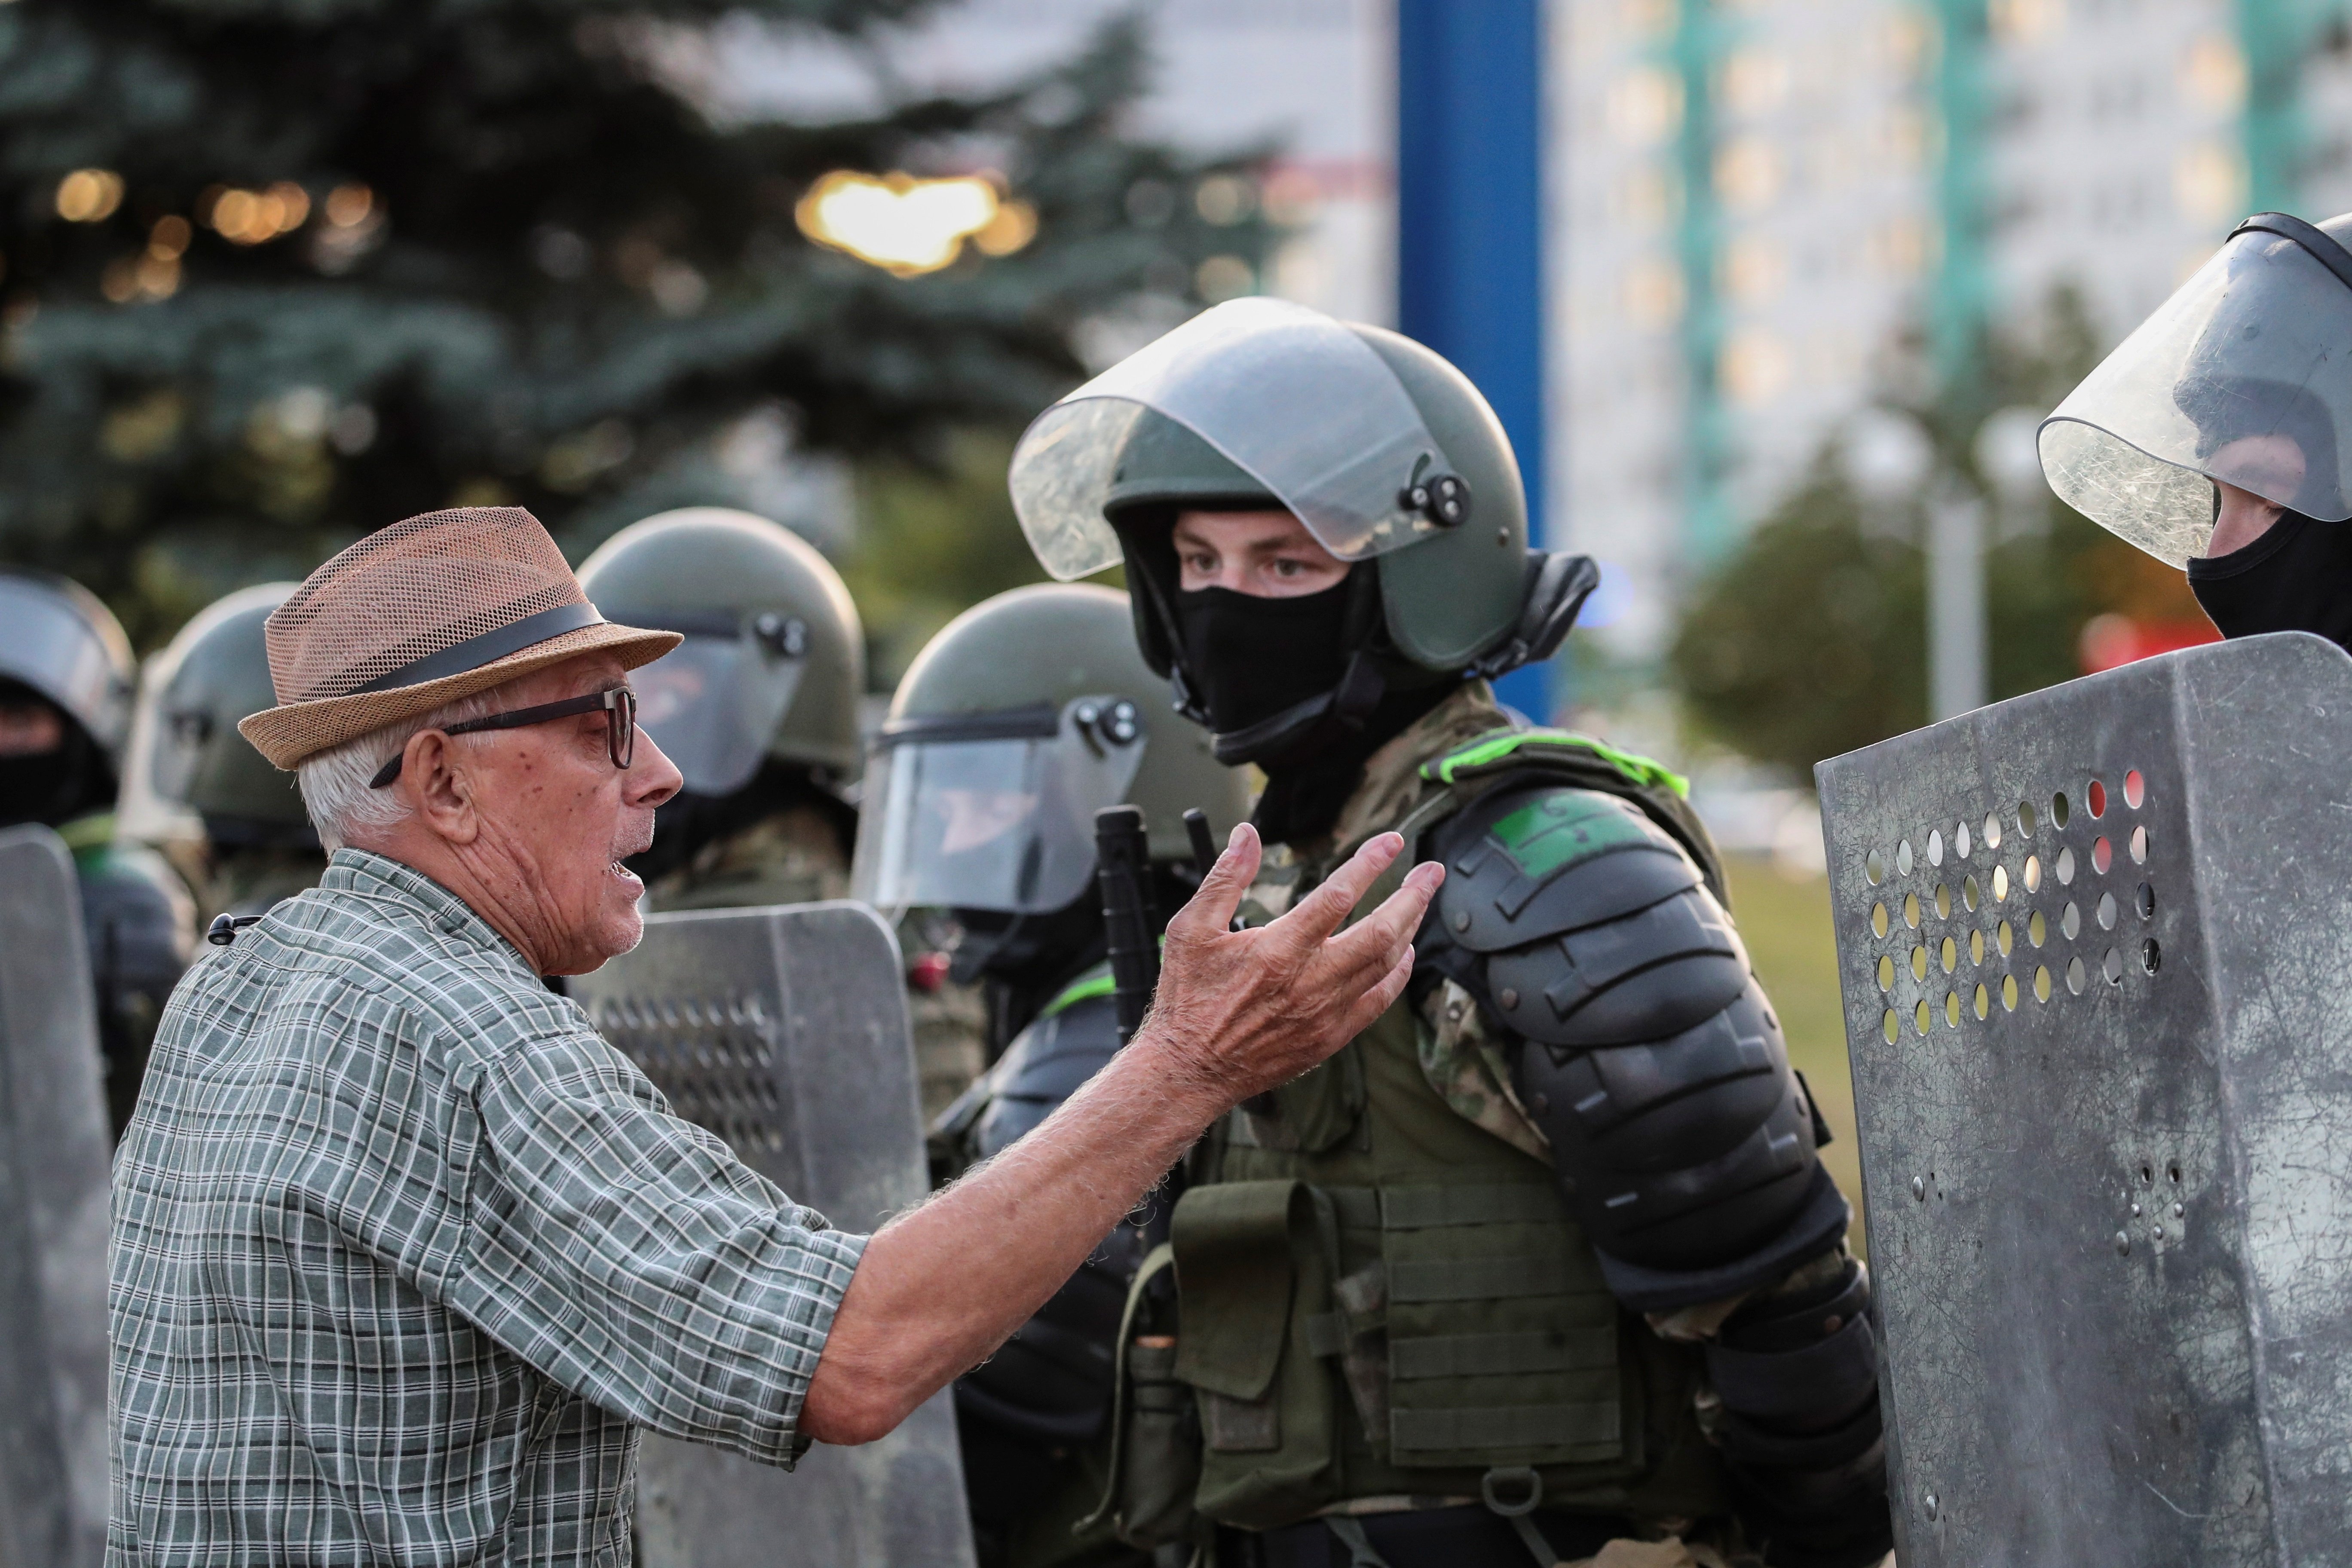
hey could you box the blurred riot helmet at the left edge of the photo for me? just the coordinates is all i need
[0,567,132,825]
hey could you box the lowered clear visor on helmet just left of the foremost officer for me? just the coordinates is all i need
[849,696,1143,915]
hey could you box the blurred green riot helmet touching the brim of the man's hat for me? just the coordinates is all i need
[581,505,866,799]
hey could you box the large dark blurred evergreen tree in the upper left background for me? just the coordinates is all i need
[0,0,1275,644]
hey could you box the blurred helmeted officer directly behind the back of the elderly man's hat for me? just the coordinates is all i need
[115,583,327,926]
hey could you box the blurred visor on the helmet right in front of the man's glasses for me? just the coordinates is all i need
[628,632,807,795]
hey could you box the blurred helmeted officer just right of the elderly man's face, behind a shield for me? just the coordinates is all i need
[581,505,983,1117]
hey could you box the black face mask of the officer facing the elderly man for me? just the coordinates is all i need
[1176,581,1350,736]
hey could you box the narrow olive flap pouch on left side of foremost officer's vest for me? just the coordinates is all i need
[1171,1180,1338,1528]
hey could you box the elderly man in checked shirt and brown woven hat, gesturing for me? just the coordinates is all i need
[108,510,1439,1566]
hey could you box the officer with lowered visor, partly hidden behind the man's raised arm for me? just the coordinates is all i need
[856,585,1249,1568]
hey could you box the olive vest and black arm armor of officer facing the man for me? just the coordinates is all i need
[1127,689,1884,1563]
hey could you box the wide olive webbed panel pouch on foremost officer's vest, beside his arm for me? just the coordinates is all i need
[1381,1180,1628,1469]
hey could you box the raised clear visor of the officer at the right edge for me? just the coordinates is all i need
[2042,230,2352,567]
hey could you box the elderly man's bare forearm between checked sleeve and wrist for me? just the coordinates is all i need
[799,1027,1225,1443]
